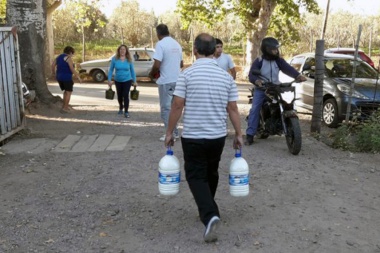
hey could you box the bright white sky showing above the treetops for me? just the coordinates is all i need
[101,0,380,17]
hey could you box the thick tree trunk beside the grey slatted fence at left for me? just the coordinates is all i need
[7,0,56,103]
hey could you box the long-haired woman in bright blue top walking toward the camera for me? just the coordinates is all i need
[108,45,137,118]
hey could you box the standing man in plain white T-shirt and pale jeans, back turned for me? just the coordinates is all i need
[149,24,183,141]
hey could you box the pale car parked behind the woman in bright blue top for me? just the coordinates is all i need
[79,48,154,83]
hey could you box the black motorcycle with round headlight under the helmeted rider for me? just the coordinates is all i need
[246,70,302,155]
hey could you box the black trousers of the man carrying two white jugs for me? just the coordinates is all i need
[181,137,226,226]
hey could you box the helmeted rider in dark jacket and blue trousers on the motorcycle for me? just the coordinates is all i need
[245,37,306,145]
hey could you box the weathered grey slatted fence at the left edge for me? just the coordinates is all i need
[0,27,25,141]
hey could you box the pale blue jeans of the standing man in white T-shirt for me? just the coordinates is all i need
[158,83,178,135]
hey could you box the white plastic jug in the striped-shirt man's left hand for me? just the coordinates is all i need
[158,147,181,195]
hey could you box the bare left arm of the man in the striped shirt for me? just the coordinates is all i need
[165,96,185,147]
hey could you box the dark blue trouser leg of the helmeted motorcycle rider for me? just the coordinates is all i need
[246,89,265,136]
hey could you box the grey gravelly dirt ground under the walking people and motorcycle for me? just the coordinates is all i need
[0,83,380,253]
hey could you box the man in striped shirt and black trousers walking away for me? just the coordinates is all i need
[165,33,243,242]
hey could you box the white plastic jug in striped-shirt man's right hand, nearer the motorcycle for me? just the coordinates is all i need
[229,149,249,197]
